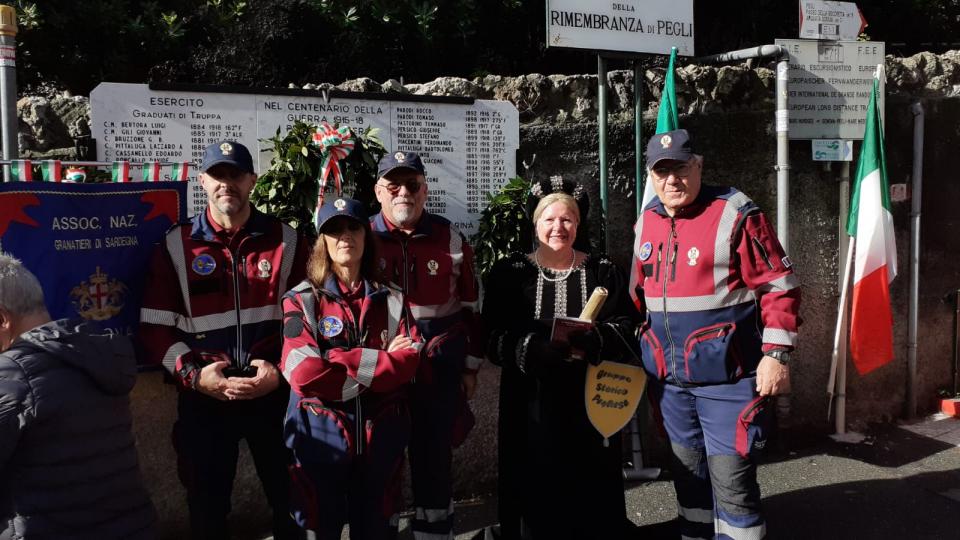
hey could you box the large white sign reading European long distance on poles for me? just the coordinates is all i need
[776,39,884,140]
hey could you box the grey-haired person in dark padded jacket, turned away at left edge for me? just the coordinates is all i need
[0,253,157,540]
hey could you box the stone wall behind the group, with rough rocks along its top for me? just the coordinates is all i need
[18,51,960,538]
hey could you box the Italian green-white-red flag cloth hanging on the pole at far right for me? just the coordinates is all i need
[847,73,897,375]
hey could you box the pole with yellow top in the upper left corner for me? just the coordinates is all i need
[0,6,19,182]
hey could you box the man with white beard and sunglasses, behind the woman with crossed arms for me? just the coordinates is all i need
[372,152,482,540]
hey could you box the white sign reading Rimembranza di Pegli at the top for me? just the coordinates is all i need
[547,0,693,56]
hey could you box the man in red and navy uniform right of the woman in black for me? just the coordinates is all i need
[630,129,800,539]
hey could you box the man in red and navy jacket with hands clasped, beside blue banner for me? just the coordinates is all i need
[139,141,308,539]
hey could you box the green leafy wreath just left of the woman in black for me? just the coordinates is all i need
[471,177,532,276]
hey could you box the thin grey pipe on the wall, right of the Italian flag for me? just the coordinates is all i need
[907,101,924,418]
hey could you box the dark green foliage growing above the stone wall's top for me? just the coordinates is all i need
[7,0,960,94]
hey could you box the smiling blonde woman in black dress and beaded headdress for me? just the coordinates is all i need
[482,177,638,540]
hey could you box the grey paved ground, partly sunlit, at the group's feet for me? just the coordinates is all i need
[388,417,960,540]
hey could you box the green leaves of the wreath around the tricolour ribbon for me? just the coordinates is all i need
[250,121,385,236]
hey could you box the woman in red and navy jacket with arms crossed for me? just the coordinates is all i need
[281,198,420,540]
